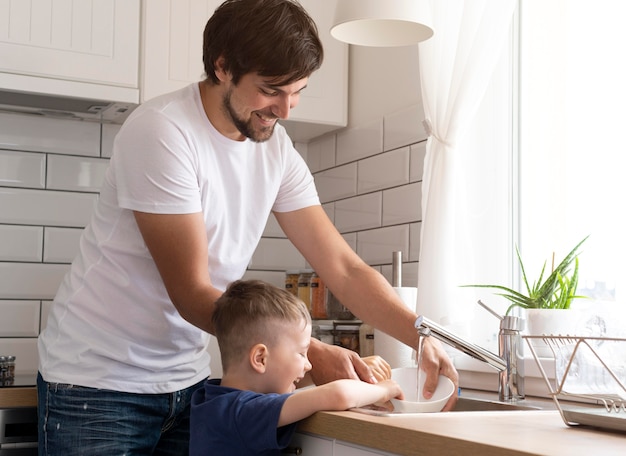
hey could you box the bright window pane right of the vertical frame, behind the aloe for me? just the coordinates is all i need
[519,0,626,313]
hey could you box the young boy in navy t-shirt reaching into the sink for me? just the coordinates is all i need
[189,280,403,456]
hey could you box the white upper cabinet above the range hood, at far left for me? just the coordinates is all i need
[0,0,140,103]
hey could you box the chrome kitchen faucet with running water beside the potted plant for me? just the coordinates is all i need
[415,301,524,402]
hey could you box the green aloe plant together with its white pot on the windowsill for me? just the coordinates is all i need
[466,236,589,356]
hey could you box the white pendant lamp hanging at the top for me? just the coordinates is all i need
[330,0,433,47]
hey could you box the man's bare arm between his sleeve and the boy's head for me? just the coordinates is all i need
[134,211,222,332]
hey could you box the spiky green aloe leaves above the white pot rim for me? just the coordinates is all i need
[465,236,589,315]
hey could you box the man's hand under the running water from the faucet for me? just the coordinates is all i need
[414,337,459,412]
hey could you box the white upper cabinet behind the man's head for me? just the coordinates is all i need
[141,0,348,142]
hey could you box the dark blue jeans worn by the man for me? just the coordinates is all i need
[37,374,203,456]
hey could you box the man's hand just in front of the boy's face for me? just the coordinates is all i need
[308,338,376,385]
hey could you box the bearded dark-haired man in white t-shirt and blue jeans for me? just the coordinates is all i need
[38,0,457,456]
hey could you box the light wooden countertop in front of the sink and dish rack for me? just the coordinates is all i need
[299,410,626,456]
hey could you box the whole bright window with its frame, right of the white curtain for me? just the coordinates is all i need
[451,0,626,384]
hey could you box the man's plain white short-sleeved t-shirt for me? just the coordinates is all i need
[39,84,319,393]
